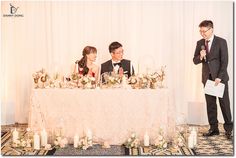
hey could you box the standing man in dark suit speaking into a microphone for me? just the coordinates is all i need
[193,20,233,139]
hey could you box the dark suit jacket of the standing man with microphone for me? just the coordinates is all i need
[193,36,229,85]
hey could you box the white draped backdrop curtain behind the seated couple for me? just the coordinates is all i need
[1,1,233,124]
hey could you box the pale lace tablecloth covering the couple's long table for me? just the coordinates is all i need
[29,89,175,144]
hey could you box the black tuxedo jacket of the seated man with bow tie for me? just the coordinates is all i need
[101,59,134,77]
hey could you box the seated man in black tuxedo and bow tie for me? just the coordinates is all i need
[101,42,134,81]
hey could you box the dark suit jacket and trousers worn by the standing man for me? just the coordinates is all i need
[193,36,233,131]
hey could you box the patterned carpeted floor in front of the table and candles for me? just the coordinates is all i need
[1,124,234,156]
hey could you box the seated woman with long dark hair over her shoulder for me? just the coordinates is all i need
[74,46,99,83]
